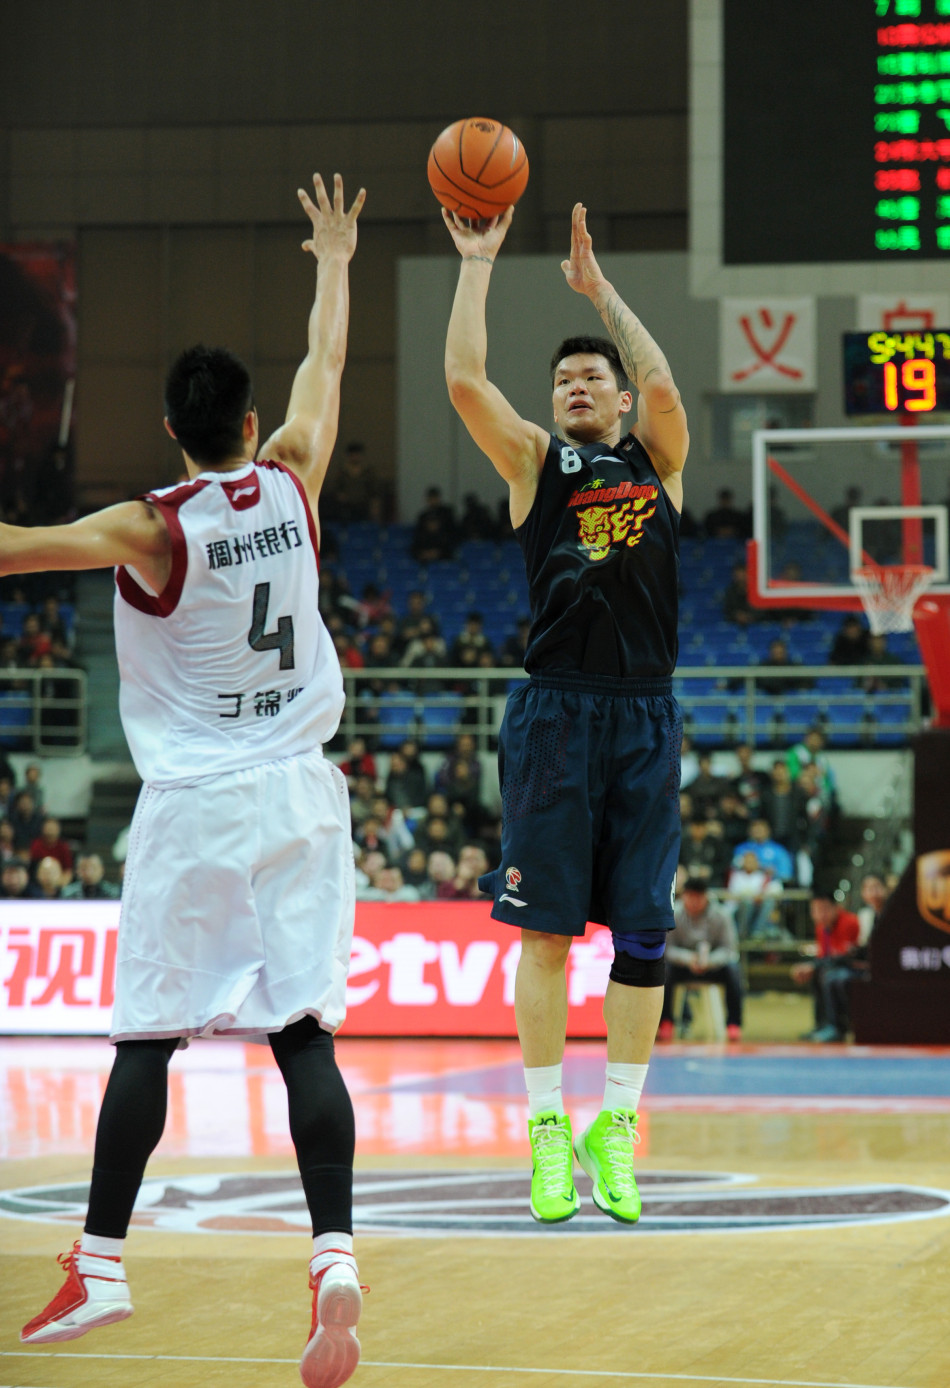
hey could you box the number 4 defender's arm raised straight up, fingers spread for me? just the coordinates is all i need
[260,174,367,505]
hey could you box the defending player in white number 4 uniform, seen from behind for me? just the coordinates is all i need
[17,175,365,1388]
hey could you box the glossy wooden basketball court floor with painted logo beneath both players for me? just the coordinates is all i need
[0,1016,950,1388]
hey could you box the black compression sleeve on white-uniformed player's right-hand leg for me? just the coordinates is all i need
[268,1016,356,1234]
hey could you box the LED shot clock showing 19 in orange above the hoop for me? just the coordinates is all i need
[844,328,950,418]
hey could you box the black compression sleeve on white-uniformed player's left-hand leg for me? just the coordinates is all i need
[85,1037,178,1238]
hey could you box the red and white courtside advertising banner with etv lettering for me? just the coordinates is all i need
[0,901,614,1037]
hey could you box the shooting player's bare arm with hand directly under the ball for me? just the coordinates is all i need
[443,208,547,525]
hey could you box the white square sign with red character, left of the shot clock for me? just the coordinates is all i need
[719,296,815,396]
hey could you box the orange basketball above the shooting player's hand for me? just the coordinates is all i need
[428,115,528,222]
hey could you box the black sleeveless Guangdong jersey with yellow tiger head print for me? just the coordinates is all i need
[515,434,679,679]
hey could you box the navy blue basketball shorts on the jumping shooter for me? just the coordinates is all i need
[479,672,683,936]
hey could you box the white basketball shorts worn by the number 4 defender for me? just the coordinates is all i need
[111,751,354,1044]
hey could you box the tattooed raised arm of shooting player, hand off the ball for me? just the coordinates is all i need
[561,203,689,491]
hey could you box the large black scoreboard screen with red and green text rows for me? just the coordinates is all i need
[722,0,950,265]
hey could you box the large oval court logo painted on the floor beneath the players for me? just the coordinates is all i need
[0,1170,950,1238]
